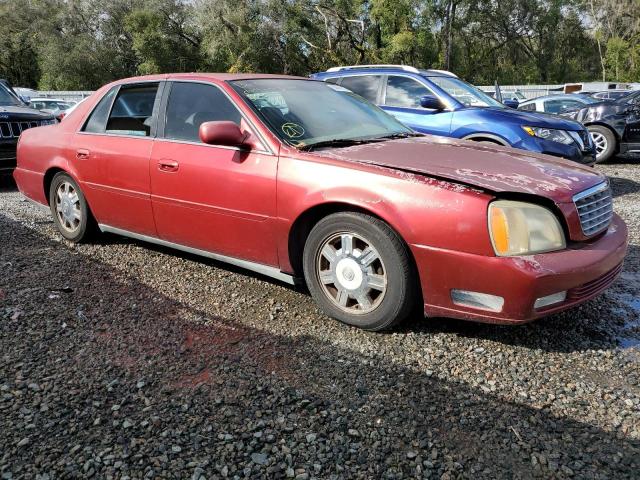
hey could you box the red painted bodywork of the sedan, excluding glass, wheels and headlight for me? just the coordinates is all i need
[15,74,627,323]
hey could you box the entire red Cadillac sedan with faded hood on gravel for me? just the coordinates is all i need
[15,74,627,330]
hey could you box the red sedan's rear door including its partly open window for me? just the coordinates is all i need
[68,82,162,236]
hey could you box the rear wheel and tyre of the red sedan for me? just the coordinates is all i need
[49,172,98,243]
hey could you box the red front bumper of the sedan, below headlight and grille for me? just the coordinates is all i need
[411,215,628,324]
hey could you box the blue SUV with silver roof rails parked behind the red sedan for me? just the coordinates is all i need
[311,65,595,165]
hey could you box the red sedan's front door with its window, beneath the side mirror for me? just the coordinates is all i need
[151,82,278,266]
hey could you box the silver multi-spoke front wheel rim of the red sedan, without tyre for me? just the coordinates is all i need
[316,232,387,314]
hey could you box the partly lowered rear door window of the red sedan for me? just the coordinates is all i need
[106,83,158,137]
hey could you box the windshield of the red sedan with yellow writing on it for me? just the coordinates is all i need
[230,79,413,148]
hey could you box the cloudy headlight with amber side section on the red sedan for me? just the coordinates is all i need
[489,200,566,257]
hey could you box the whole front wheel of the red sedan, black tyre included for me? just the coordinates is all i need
[302,212,419,331]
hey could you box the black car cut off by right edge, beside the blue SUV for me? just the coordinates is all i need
[561,90,640,163]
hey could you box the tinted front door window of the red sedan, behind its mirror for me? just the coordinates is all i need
[164,82,242,142]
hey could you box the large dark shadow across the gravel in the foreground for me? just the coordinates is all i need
[0,215,640,478]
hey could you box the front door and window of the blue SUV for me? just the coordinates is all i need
[382,75,453,136]
